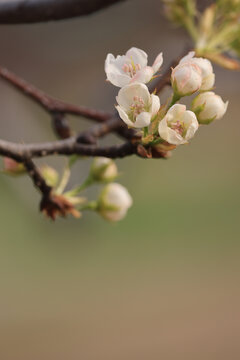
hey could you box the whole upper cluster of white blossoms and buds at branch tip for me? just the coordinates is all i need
[105,47,228,145]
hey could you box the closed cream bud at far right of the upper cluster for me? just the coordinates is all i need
[192,91,228,124]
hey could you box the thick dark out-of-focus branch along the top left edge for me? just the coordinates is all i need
[0,0,125,24]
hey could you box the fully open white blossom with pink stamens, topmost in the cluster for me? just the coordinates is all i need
[105,47,163,87]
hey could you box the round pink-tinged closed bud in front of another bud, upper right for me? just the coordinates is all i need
[171,62,202,97]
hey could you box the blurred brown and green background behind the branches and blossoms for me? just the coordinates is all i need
[0,0,240,360]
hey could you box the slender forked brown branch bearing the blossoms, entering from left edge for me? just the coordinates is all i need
[0,60,175,201]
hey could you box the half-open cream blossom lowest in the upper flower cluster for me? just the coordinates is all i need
[158,104,199,145]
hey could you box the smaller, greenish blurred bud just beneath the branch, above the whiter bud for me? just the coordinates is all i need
[91,157,118,182]
